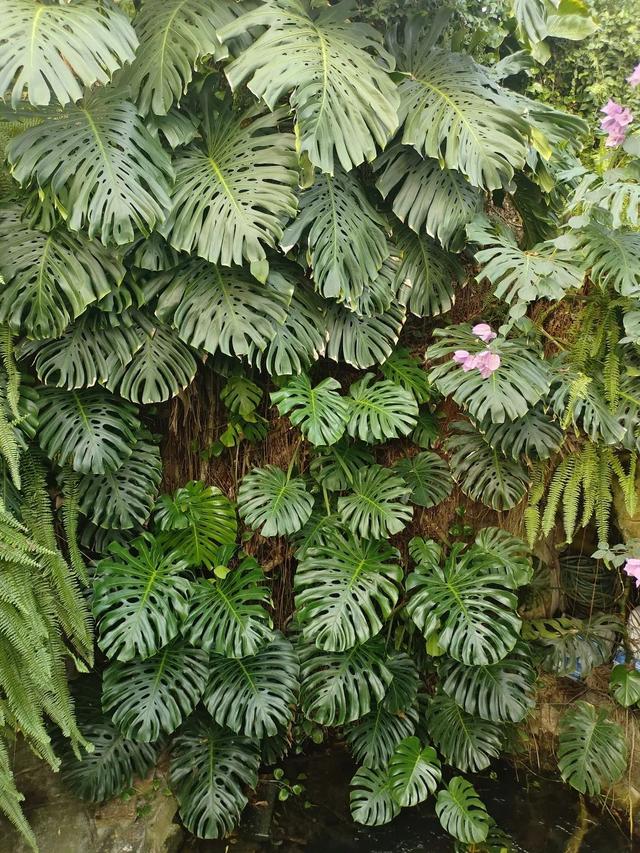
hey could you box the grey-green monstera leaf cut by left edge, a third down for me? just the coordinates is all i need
[0,206,124,339]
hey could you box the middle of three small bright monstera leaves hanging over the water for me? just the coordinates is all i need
[389,737,442,808]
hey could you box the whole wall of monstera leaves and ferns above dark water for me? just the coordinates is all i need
[0,0,640,848]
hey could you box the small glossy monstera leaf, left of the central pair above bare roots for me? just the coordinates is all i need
[271,374,348,445]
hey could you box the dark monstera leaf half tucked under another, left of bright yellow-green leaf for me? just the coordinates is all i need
[78,434,162,530]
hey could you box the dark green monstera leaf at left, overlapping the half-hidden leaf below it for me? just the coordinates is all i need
[38,388,140,474]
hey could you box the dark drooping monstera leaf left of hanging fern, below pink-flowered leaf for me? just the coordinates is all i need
[445,421,529,510]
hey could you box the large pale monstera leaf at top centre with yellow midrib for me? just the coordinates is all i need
[218,0,398,173]
